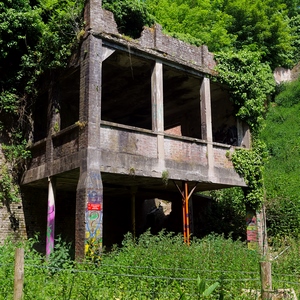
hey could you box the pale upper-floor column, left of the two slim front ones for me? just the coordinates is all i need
[151,60,164,160]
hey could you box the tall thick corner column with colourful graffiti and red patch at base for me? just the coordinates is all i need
[75,35,103,259]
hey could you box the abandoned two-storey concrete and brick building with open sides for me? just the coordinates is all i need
[5,0,250,257]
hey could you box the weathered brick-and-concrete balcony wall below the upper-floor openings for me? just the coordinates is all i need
[23,121,245,189]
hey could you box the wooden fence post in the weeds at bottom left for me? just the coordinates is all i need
[14,248,24,300]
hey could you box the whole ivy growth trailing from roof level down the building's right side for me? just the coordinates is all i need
[216,50,275,209]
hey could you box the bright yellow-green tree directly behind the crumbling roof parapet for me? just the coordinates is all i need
[146,0,235,52]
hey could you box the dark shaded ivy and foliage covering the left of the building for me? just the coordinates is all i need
[0,0,85,203]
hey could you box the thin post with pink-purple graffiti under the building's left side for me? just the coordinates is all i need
[46,177,56,258]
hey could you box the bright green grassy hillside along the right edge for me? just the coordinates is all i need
[261,80,300,236]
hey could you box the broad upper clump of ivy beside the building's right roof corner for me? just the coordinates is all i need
[215,49,275,135]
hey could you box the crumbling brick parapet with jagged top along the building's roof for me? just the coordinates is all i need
[85,0,216,73]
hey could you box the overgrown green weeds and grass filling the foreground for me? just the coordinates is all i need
[0,232,300,300]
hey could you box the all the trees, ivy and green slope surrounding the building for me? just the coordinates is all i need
[0,0,300,238]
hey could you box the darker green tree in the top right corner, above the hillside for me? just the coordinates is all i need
[224,0,293,68]
